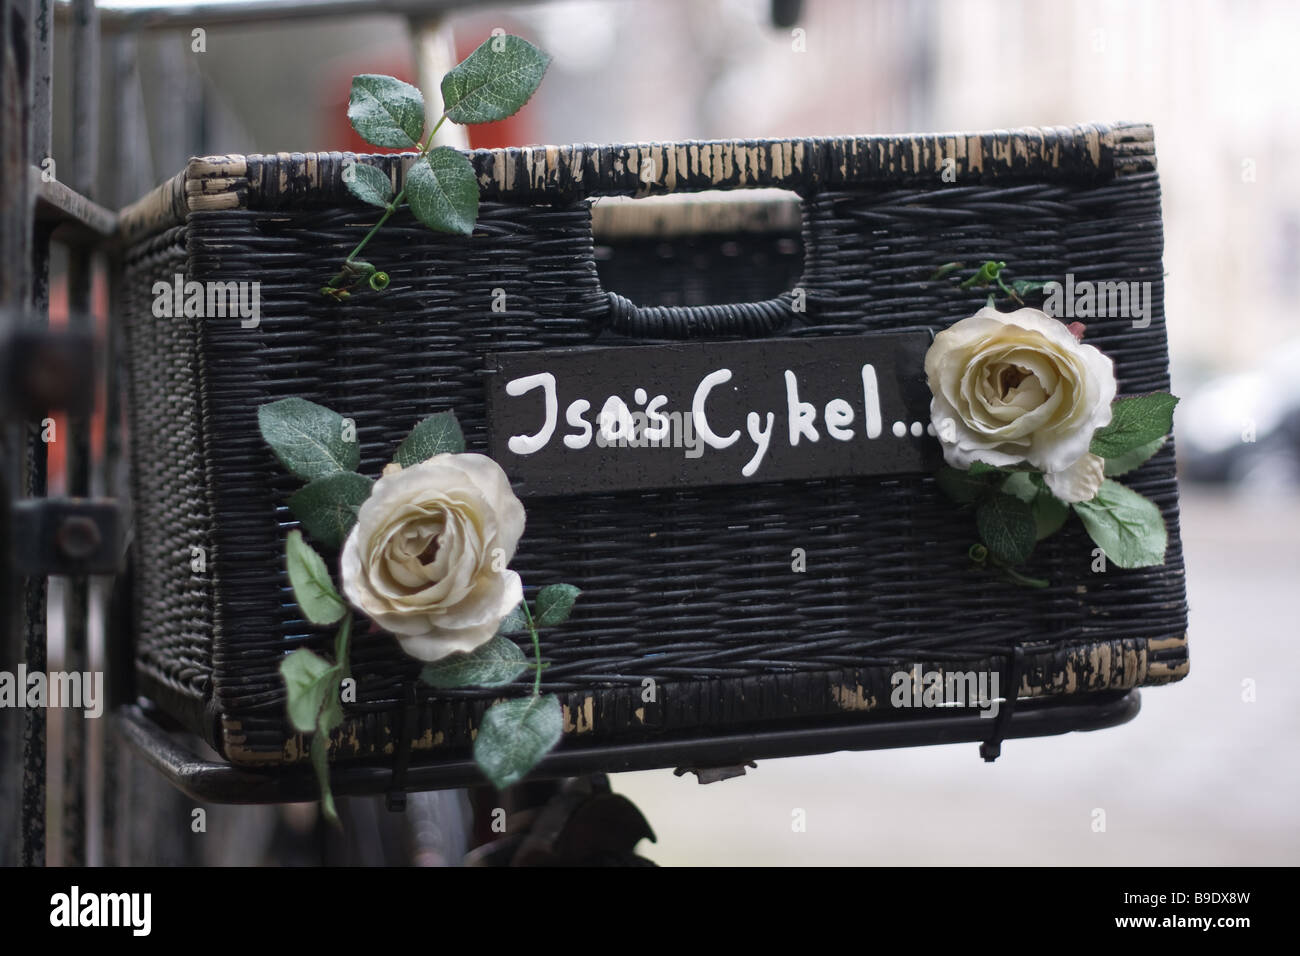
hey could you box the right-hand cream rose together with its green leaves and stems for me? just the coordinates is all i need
[926,261,1178,588]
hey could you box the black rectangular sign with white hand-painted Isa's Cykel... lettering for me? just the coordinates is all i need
[488,329,940,496]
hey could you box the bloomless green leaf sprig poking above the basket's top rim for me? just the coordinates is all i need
[321,34,550,300]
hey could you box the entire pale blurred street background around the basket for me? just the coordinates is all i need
[38,0,1300,865]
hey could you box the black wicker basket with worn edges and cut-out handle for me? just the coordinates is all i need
[122,125,1187,763]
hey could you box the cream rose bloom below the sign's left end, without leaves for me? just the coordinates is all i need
[339,454,524,661]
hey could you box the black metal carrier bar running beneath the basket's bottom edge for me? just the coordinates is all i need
[116,691,1141,804]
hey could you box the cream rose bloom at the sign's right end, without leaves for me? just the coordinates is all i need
[926,307,1115,502]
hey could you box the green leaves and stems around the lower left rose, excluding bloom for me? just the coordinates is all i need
[257,398,581,825]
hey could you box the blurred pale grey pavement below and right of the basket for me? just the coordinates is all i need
[614,485,1300,866]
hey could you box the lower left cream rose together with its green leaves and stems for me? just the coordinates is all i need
[257,398,580,823]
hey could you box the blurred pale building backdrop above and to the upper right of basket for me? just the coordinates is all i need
[68,0,1300,388]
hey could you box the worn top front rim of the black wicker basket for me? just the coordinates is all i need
[118,122,1156,242]
